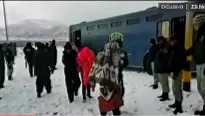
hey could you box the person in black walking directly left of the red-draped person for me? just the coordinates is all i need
[62,42,80,103]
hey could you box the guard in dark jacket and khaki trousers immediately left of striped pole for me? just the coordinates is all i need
[169,36,186,114]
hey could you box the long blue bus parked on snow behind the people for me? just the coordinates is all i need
[69,7,186,68]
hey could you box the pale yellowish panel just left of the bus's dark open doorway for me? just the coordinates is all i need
[156,20,170,38]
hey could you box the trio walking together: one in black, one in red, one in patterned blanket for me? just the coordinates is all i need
[62,32,128,116]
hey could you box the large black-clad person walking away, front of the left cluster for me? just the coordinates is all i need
[34,43,52,98]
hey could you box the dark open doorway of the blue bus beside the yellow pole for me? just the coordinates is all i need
[171,16,186,46]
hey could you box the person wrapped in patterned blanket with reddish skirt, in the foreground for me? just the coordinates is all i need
[90,33,128,116]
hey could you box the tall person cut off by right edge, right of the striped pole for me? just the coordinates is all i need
[187,14,205,115]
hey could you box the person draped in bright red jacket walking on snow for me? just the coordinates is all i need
[77,46,95,102]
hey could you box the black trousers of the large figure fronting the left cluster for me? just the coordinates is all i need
[36,76,52,94]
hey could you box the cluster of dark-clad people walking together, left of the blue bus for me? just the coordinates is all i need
[23,40,57,98]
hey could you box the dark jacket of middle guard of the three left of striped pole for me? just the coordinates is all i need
[154,48,172,73]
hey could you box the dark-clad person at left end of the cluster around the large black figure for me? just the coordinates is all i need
[23,42,35,77]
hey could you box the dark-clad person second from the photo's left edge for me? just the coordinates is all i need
[5,44,14,81]
